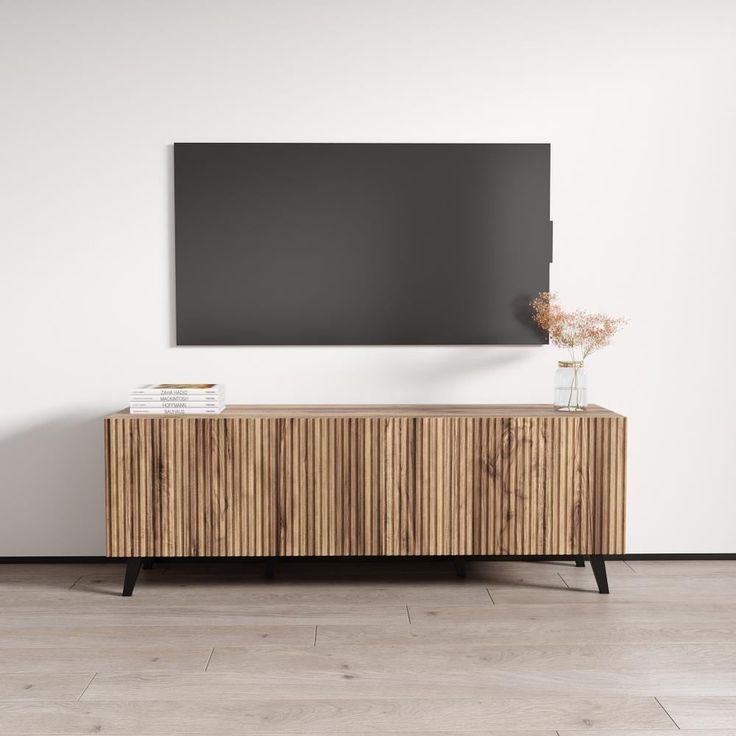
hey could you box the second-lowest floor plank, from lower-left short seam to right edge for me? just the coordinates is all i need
[82,660,736,702]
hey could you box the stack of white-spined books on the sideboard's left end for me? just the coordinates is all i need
[130,383,225,414]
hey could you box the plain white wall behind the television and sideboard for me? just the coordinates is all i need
[0,0,736,555]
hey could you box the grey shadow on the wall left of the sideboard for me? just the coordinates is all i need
[0,415,105,557]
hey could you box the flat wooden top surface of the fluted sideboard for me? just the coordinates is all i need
[108,404,621,419]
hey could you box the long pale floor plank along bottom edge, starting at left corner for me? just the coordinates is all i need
[0,696,676,736]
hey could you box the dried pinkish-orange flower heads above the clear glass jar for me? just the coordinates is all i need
[531,291,626,362]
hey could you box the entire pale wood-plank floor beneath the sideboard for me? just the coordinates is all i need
[0,560,736,736]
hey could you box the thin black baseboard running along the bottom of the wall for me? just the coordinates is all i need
[0,552,736,565]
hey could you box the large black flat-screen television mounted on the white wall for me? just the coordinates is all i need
[174,143,552,345]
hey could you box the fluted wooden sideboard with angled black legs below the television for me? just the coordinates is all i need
[105,405,626,595]
